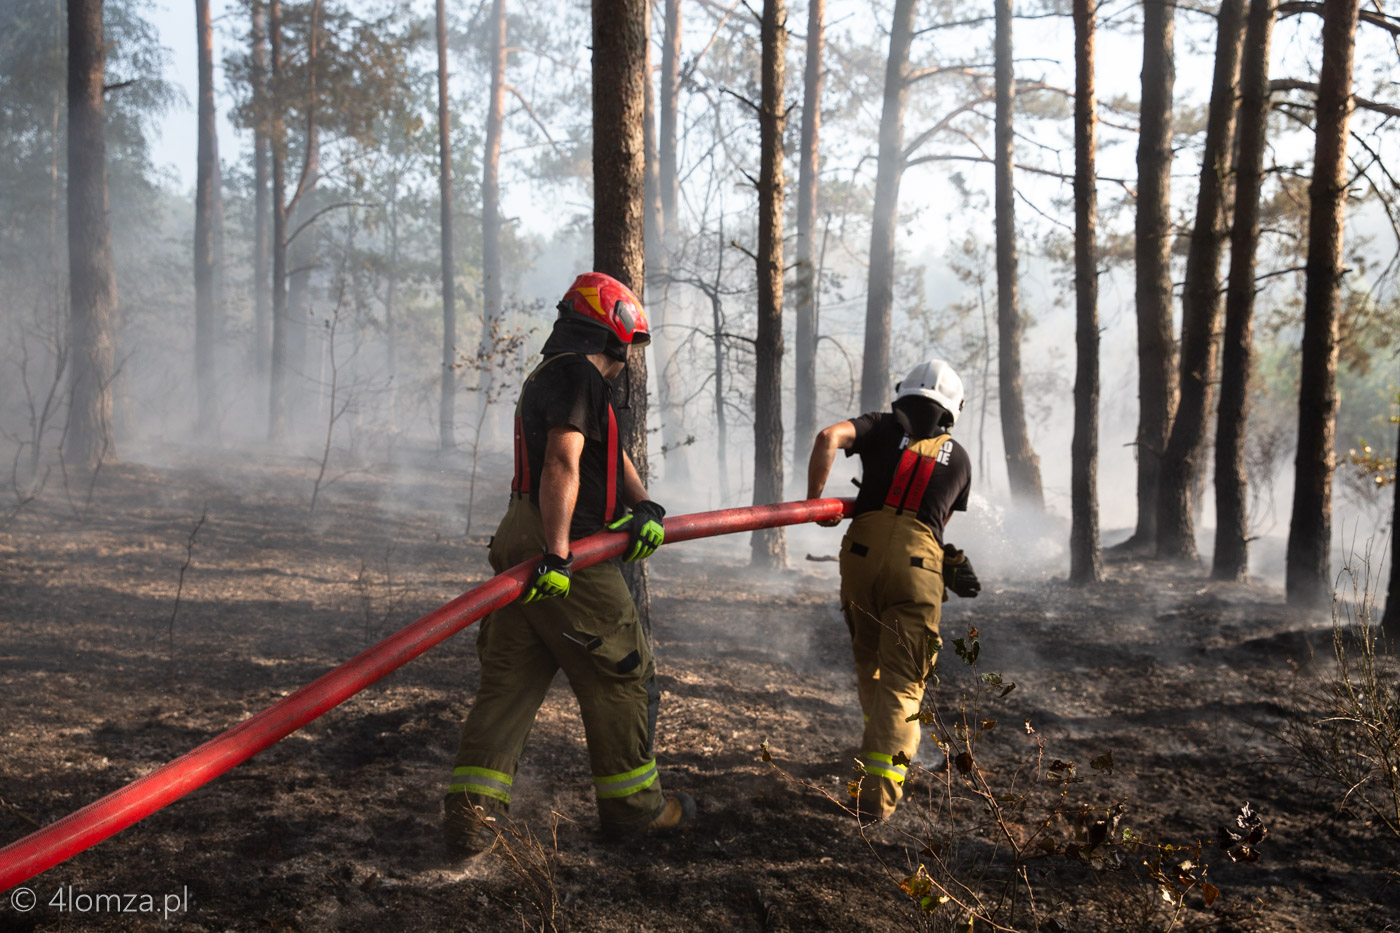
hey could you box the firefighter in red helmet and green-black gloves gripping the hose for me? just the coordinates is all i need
[442,272,694,859]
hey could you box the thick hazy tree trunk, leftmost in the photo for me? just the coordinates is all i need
[63,0,116,471]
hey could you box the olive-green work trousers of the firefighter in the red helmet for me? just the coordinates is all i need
[448,496,665,832]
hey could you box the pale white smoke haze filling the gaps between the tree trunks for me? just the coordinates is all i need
[0,3,1397,602]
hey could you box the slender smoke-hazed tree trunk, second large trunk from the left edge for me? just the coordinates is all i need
[195,0,220,436]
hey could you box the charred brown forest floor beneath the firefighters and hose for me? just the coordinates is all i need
[0,448,1400,933]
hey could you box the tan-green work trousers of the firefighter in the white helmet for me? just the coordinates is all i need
[841,507,944,820]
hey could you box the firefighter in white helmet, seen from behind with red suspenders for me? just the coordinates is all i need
[806,360,981,820]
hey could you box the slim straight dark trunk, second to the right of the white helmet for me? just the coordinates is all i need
[1069,0,1103,583]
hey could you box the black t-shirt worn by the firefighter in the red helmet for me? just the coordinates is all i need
[519,353,626,541]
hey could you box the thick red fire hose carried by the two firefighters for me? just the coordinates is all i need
[0,499,853,891]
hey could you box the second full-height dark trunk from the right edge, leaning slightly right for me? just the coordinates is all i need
[1211,0,1278,580]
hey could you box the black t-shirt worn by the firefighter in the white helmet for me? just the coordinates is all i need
[846,412,972,544]
